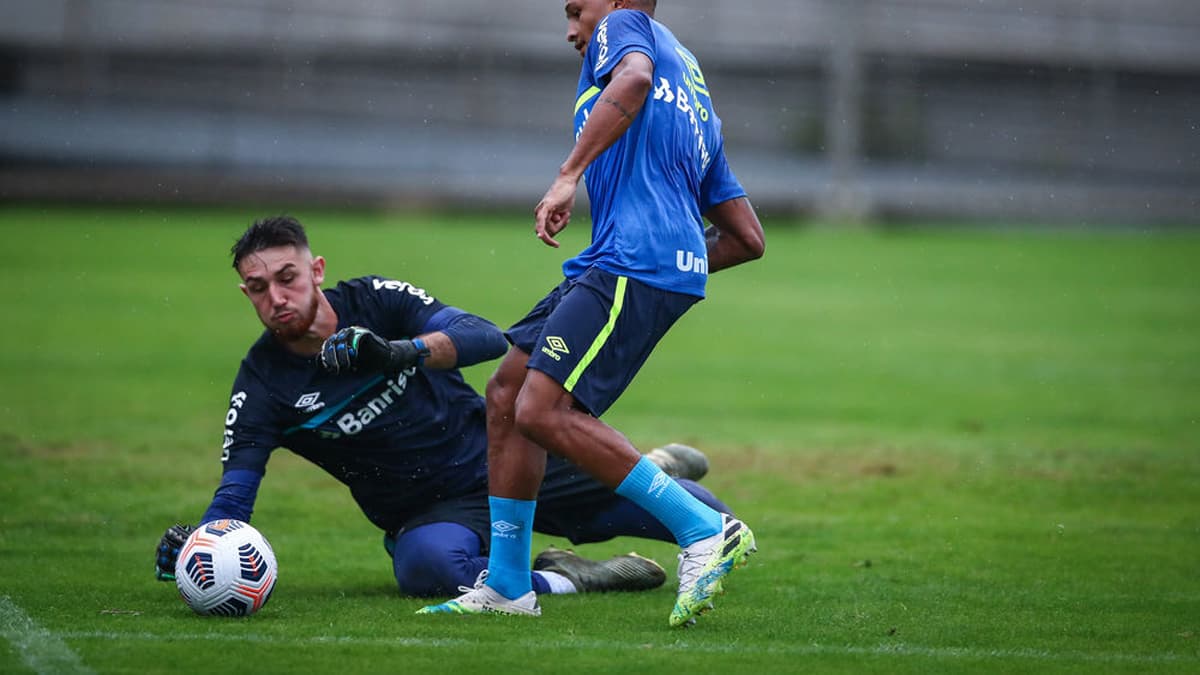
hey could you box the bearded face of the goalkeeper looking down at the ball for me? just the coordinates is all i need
[238,246,325,341]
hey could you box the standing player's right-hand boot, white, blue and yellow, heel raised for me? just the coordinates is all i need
[670,513,758,626]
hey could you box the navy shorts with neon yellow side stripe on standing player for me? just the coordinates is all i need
[504,267,700,417]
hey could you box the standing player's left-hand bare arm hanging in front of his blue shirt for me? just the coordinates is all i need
[534,52,654,249]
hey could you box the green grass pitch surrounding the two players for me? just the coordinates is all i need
[0,201,1200,673]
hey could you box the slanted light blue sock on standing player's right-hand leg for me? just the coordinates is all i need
[617,456,721,546]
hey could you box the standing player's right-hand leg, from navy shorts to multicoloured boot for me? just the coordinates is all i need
[516,268,754,625]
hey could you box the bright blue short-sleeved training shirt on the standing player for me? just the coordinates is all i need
[563,10,745,297]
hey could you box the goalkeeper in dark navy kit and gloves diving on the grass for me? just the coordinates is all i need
[155,216,724,596]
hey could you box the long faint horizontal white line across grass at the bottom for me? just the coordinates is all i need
[54,632,1200,664]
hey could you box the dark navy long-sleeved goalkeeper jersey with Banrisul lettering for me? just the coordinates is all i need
[211,276,487,531]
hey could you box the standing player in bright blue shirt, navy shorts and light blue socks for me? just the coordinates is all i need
[421,0,763,626]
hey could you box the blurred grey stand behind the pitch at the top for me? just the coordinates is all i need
[0,0,1200,225]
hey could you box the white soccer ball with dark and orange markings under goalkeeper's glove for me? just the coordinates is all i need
[175,520,278,616]
